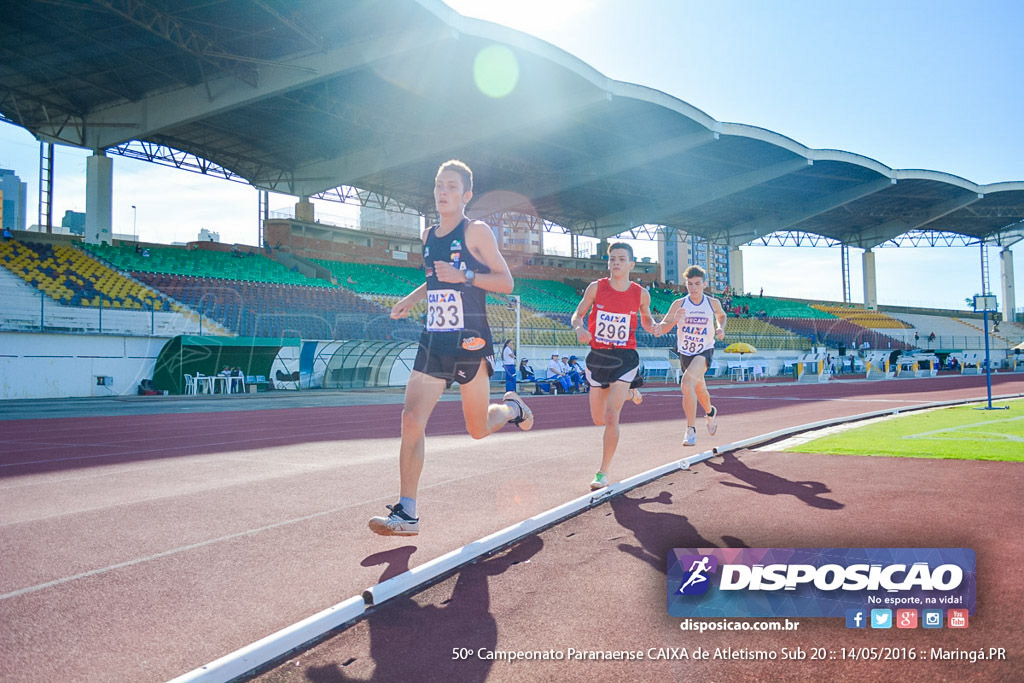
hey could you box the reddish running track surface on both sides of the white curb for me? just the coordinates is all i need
[0,376,1024,681]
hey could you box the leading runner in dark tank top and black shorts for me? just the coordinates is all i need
[370,160,534,536]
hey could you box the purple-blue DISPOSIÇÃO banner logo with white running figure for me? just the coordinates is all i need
[668,548,976,628]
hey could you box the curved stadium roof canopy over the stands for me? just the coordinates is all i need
[0,0,1024,248]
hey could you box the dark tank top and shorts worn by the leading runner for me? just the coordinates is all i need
[423,218,494,356]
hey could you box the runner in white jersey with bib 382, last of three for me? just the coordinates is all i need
[658,265,726,445]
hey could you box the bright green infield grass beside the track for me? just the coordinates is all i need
[785,399,1024,462]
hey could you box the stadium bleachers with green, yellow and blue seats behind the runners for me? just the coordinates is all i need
[6,235,1007,350]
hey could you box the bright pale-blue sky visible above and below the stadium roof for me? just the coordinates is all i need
[0,0,1024,308]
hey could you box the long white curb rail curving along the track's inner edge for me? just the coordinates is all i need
[170,394,1024,683]
